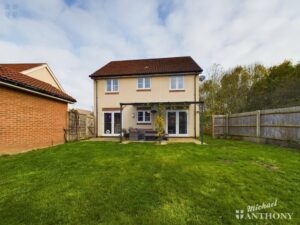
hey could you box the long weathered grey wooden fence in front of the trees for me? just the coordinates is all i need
[212,106,300,148]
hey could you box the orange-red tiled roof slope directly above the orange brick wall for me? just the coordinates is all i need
[0,64,76,102]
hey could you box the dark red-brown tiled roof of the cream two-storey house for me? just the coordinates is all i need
[90,56,203,78]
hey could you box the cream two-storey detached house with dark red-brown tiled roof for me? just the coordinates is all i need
[90,57,202,140]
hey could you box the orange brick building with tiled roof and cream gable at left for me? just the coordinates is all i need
[0,63,76,154]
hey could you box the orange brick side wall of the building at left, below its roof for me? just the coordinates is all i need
[0,86,67,154]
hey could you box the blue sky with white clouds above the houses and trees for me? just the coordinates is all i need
[0,0,300,110]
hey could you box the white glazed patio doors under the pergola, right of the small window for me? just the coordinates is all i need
[166,110,188,136]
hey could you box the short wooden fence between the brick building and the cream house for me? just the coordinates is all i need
[65,110,95,141]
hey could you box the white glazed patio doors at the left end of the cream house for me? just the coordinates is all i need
[103,112,121,136]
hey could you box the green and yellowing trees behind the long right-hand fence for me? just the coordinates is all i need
[199,61,300,135]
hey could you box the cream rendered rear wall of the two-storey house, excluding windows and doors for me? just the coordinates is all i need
[94,74,199,136]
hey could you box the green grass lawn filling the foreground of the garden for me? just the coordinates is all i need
[0,138,300,225]
